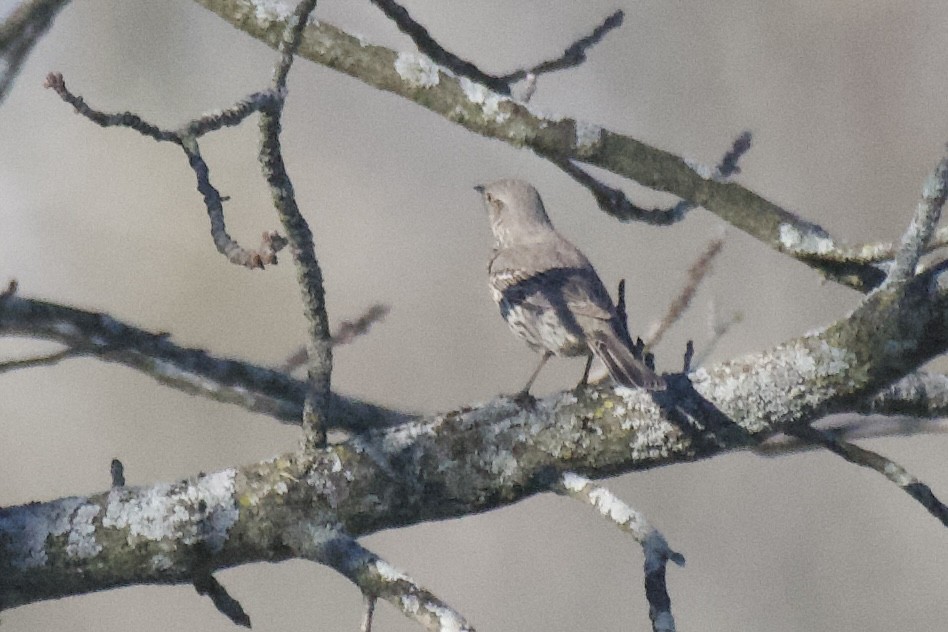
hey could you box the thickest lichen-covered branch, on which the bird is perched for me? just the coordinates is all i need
[0,260,948,607]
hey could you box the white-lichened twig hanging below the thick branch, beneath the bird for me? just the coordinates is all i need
[556,472,685,632]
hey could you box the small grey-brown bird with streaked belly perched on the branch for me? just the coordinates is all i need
[474,179,666,396]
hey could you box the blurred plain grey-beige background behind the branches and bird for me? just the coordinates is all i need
[0,0,948,632]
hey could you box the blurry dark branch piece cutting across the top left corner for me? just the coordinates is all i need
[0,0,69,103]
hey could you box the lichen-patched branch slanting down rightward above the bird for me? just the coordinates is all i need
[196,0,888,292]
